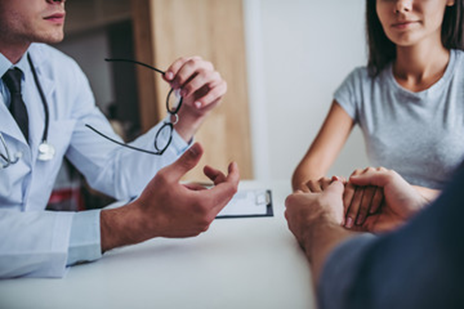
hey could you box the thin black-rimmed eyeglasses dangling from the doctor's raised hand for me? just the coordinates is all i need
[85,59,182,155]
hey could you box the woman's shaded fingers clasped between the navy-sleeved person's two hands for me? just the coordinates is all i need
[343,167,387,228]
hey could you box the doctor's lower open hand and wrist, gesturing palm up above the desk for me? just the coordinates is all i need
[100,143,240,252]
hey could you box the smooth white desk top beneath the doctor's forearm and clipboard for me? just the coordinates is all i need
[0,181,315,309]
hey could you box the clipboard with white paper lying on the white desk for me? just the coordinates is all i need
[216,189,274,219]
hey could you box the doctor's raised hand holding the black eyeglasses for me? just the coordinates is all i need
[164,56,227,142]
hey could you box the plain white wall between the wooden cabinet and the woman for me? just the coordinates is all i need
[244,0,367,179]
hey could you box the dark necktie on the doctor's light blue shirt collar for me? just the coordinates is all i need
[2,68,29,142]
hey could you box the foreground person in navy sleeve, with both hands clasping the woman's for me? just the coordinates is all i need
[286,171,464,309]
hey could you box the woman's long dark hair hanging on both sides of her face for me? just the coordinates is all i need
[366,0,464,77]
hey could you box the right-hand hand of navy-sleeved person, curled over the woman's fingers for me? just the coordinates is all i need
[349,169,429,233]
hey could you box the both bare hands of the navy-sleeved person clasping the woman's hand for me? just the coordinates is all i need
[285,169,427,283]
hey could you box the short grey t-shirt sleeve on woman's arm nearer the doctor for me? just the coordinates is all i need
[334,68,364,122]
